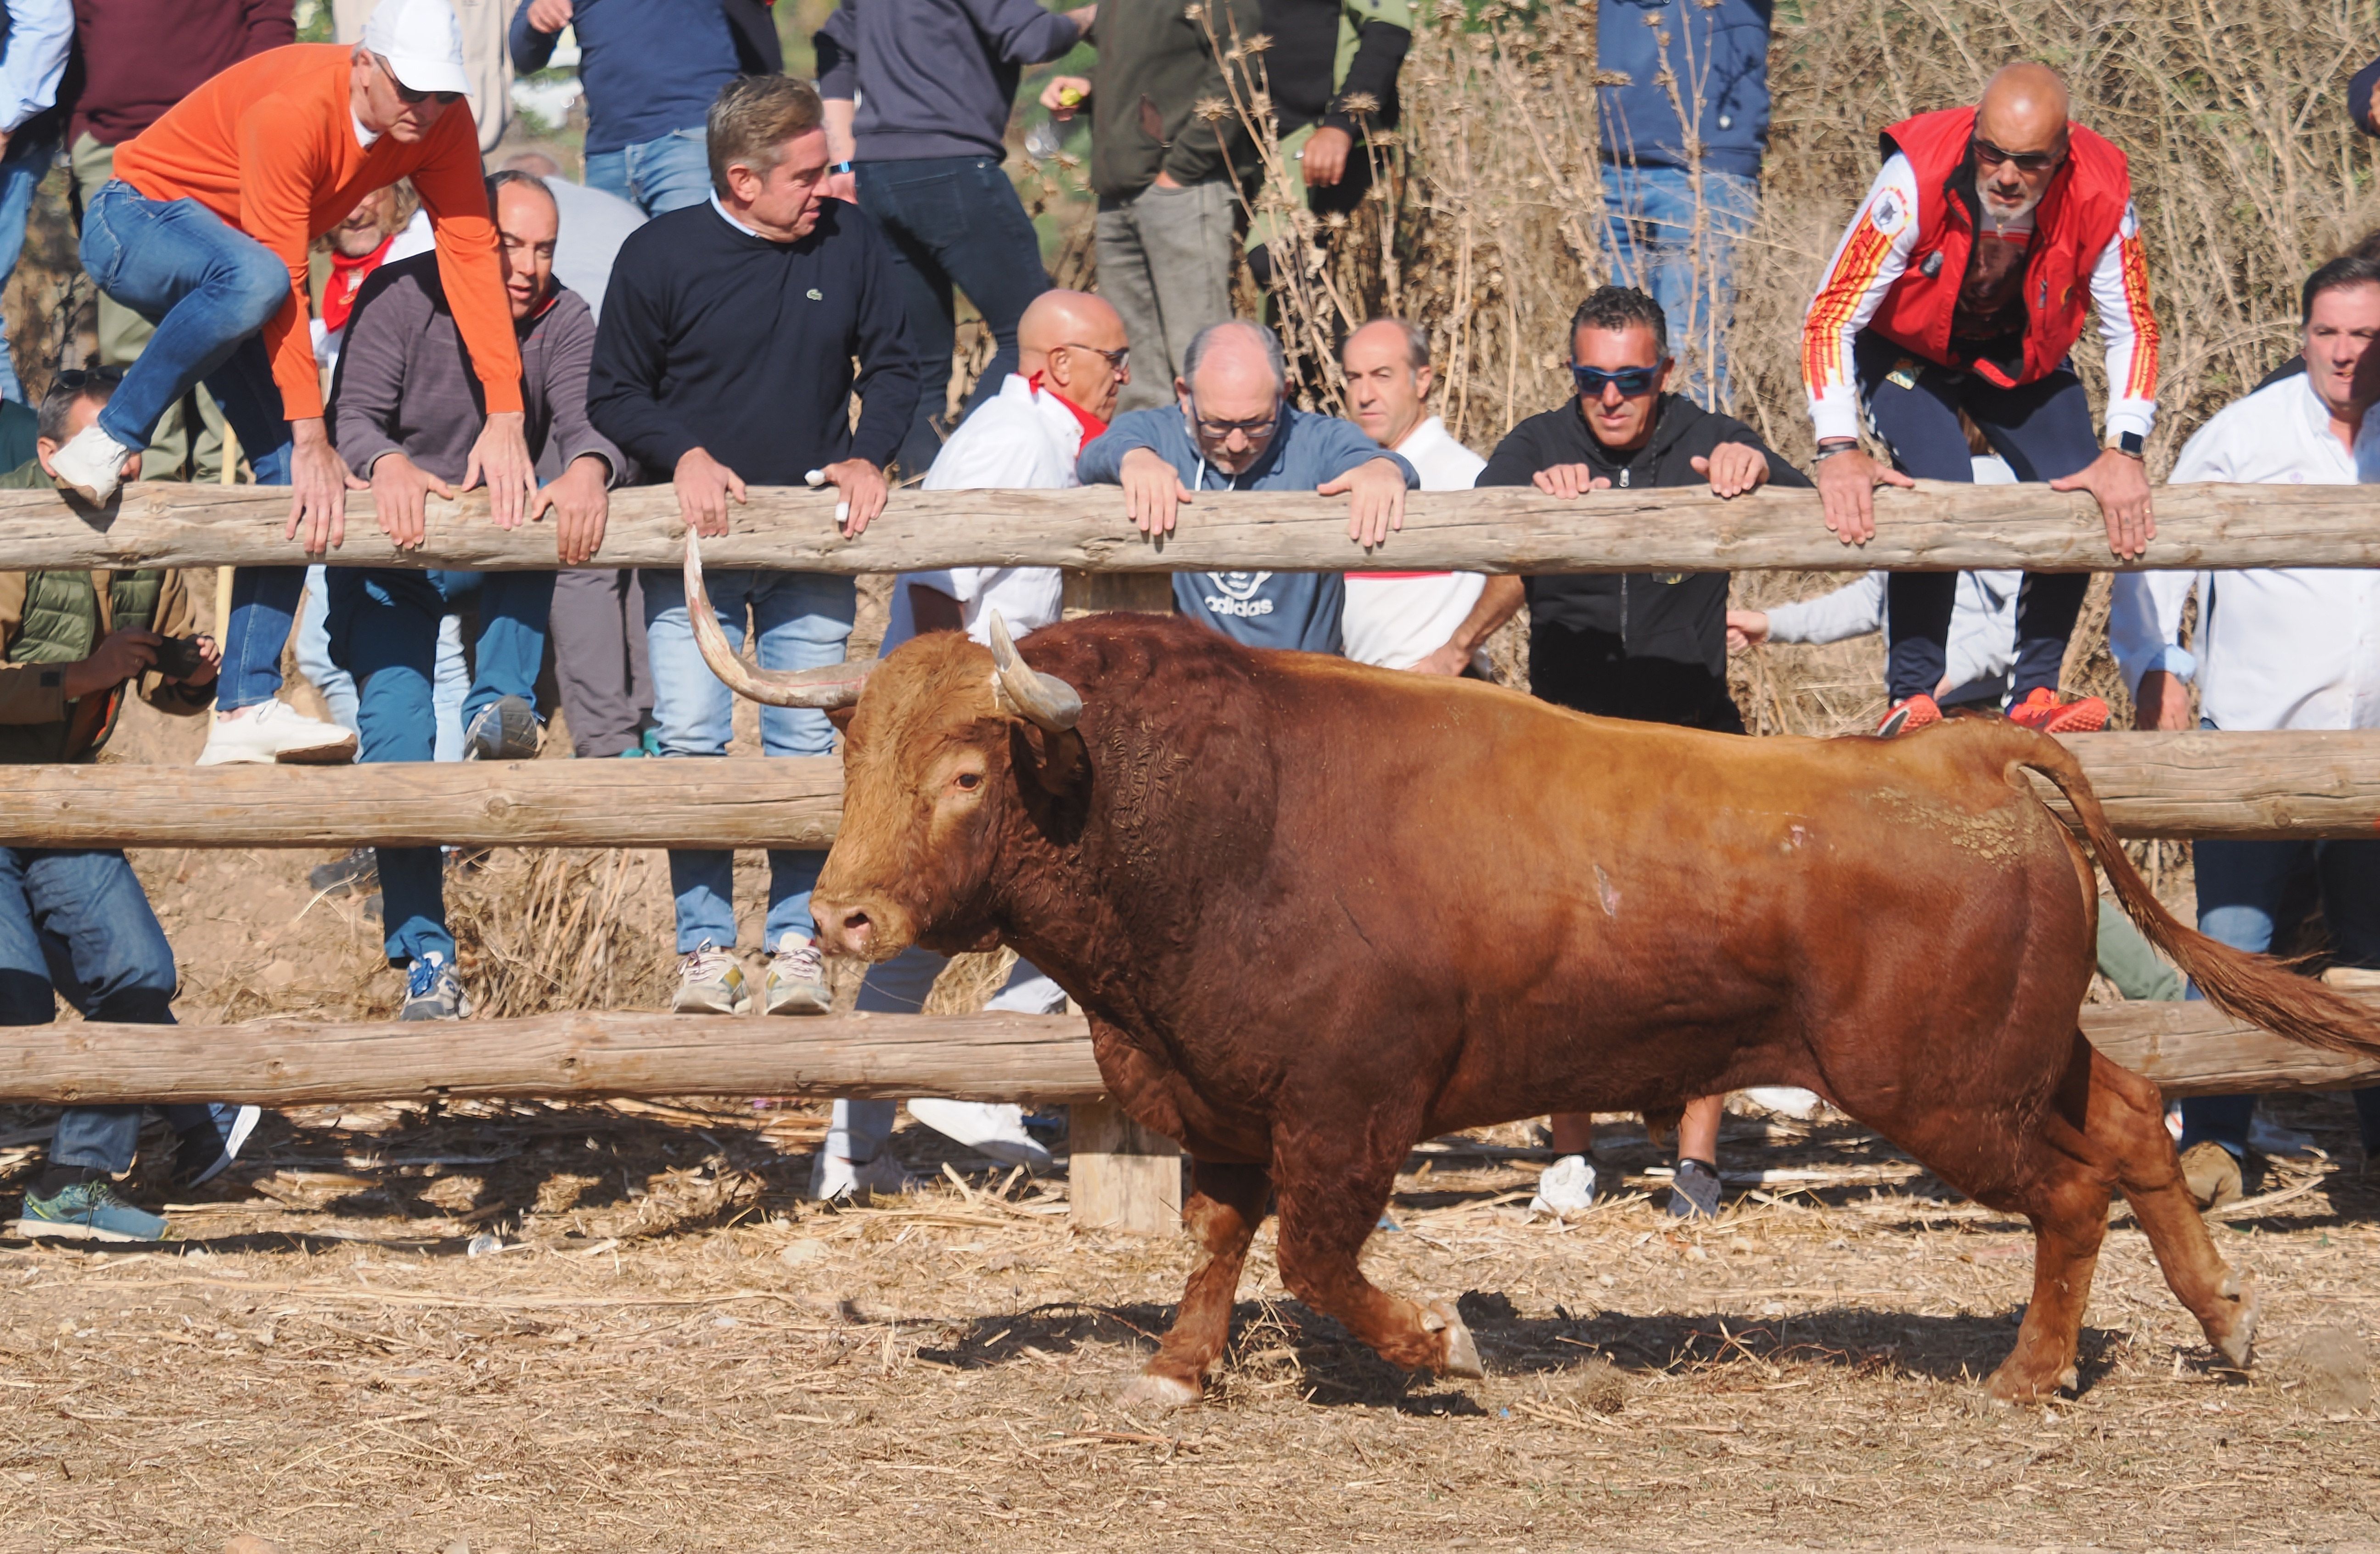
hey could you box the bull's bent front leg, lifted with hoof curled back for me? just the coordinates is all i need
[1273,1133,1483,1375]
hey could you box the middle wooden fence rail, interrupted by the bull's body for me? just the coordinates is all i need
[0,731,2380,847]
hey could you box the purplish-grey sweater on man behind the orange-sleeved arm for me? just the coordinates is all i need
[324,254,629,483]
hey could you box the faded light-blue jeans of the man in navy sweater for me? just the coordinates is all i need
[643,571,859,954]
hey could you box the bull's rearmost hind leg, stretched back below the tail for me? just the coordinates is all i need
[2085,1052,2259,1368]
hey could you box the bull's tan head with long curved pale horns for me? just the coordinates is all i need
[685,528,1083,962]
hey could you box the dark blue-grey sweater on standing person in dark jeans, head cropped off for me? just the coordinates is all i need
[814,0,1083,162]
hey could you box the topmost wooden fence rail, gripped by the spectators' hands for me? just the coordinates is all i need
[14,481,2380,574]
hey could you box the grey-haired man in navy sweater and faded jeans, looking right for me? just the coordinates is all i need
[588,76,919,1014]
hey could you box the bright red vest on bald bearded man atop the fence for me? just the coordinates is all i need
[1868,107,2133,388]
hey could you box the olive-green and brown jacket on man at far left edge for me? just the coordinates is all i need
[0,459,214,766]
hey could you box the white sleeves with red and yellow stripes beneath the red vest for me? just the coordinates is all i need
[1802,152,2156,440]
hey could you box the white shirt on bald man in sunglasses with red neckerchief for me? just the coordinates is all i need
[881,374,1083,652]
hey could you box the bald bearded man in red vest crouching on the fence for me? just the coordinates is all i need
[1802,64,2156,733]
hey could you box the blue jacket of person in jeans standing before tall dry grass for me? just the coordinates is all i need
[1594,0,1775,179]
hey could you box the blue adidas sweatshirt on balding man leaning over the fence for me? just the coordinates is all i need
[1076,405,1421,652]
